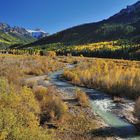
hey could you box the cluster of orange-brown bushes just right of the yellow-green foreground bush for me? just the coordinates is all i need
[33,86,67,124]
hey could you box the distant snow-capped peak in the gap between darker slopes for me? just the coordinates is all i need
[27,29,48,39]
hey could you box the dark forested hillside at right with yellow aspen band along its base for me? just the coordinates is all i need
[15,1,140,60]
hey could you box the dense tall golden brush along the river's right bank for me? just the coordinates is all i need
[63,59,140,98]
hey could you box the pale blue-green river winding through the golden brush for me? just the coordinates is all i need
[49,66,140,140]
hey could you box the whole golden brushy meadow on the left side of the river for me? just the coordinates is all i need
[0,54,110,140]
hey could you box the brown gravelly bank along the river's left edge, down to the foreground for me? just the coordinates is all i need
[26,75,115,140]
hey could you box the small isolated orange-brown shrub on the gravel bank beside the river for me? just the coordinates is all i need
[76,89,89,107]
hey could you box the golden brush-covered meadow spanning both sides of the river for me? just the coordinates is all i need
[0,52,140,140]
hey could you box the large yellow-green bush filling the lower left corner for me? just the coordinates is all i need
[0,79,52,140]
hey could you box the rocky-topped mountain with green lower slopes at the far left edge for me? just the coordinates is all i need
[0,23,35,48]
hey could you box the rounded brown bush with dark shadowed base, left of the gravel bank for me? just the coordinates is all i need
[40,88,67,123]
